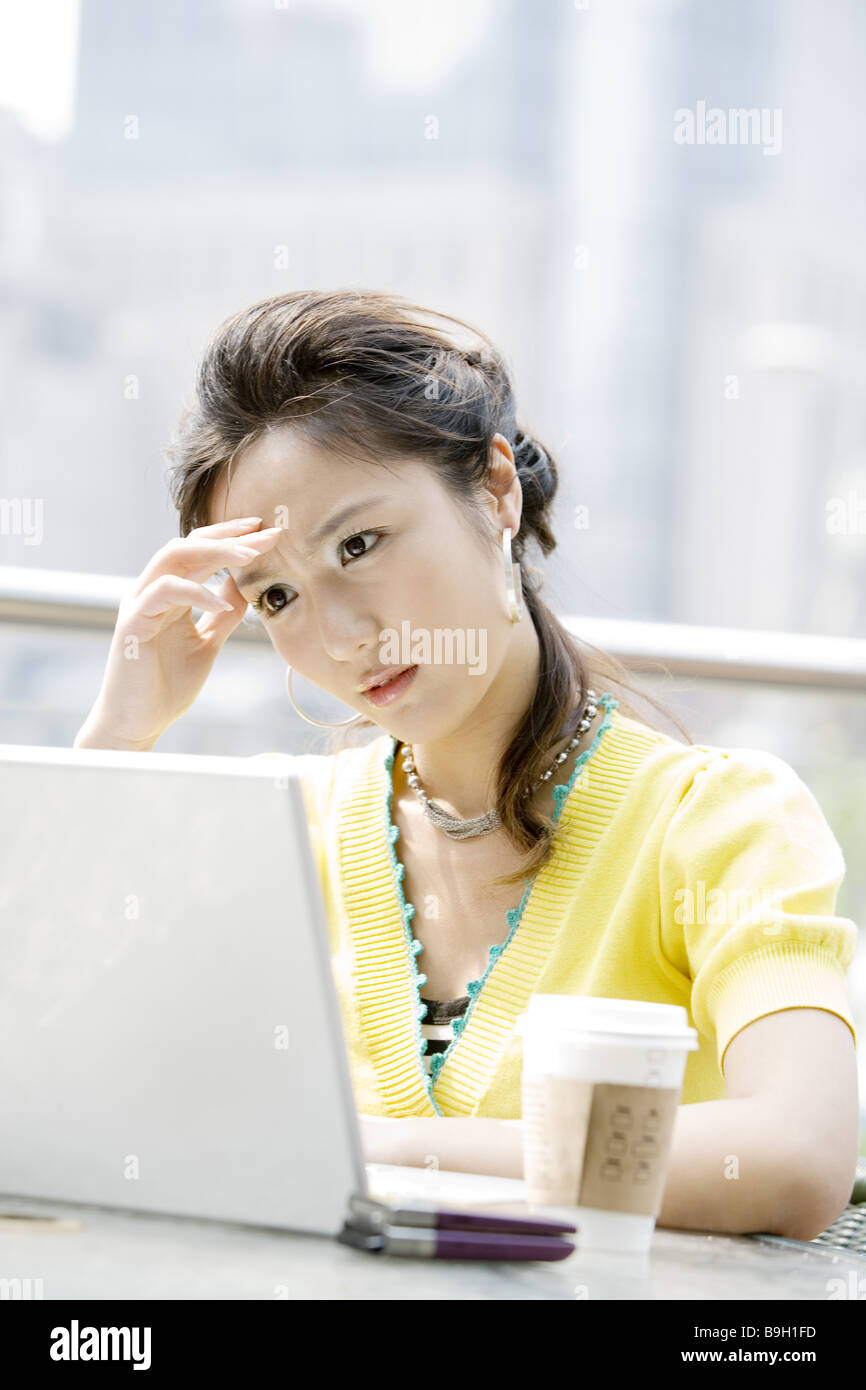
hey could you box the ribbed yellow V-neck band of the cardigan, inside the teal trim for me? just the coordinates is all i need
[338,694,617,1116]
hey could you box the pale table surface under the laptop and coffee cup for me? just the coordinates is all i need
[0,1165,866,1301]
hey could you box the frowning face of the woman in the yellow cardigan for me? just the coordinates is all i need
[209,430,525,742]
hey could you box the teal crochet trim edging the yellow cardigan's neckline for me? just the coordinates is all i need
[385,694,619,1095]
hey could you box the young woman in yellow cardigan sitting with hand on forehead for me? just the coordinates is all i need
[76,291,858,1238]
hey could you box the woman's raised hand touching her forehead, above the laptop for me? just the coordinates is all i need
[74,517,281,752]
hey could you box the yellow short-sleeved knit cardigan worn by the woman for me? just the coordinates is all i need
[254,695,856,1119]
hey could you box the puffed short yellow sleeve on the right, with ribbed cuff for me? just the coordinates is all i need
[659,748,858,1074]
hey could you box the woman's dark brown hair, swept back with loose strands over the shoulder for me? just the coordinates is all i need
[165,289,692,884]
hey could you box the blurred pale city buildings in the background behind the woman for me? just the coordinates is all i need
[0,0,866,1152]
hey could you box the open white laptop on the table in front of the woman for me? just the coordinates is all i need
[0,744,524,1236]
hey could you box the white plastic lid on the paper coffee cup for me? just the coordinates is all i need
[516,994,698,1048]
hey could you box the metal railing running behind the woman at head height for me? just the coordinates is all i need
[0,566,866,691]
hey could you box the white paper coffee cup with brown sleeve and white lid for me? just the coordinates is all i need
[516,994,698,1251]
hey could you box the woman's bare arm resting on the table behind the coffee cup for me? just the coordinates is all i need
[361,1006,858,1240]
